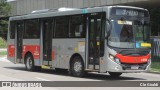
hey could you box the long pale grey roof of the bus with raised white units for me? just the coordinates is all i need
[9,5,146,21]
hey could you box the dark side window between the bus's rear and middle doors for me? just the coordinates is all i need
[24,19,40,39]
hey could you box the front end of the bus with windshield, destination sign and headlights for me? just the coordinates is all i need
[106,6,151,76]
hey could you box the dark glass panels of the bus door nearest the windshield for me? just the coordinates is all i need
[89,18,101,65]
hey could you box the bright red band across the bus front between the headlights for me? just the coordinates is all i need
[116,54,150,64]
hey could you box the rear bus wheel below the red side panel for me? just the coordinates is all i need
[25,54,35,71]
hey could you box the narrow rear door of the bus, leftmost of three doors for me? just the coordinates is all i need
[15,22,24,63]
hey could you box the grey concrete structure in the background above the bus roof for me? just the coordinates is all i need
[10,0,150,16]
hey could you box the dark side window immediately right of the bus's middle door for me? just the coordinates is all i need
[55,17,69,38]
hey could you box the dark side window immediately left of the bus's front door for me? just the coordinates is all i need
[69,15,85,38]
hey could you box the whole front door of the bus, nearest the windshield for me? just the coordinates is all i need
[87,13,104,70]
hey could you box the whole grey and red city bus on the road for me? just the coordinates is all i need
[7,5,151,77]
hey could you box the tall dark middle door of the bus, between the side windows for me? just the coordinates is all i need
[42,19,53,66]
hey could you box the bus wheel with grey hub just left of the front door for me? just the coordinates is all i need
[71,56,84,77]
